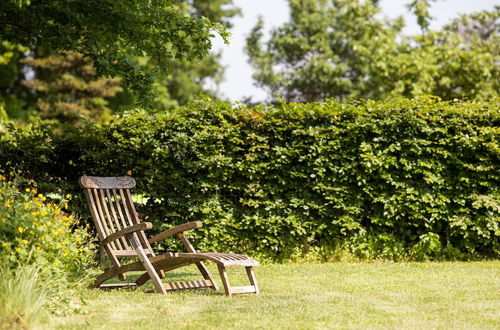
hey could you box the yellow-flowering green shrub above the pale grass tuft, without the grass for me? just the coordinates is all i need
[0,175,93,277]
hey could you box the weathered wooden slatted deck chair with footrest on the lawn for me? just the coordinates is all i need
[79,176,259,296]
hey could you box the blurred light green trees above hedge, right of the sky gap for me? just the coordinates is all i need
[246,0,500,102]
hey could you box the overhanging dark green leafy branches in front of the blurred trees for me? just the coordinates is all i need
[0,0,228,100]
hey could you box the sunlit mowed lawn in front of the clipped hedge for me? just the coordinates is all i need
[51,261,500,329]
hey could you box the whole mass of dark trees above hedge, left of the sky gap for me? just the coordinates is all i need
[0,0,239,122]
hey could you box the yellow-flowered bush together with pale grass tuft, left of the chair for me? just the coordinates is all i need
[0,177,95,328]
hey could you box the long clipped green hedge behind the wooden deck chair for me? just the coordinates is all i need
[0,97,500,260]
